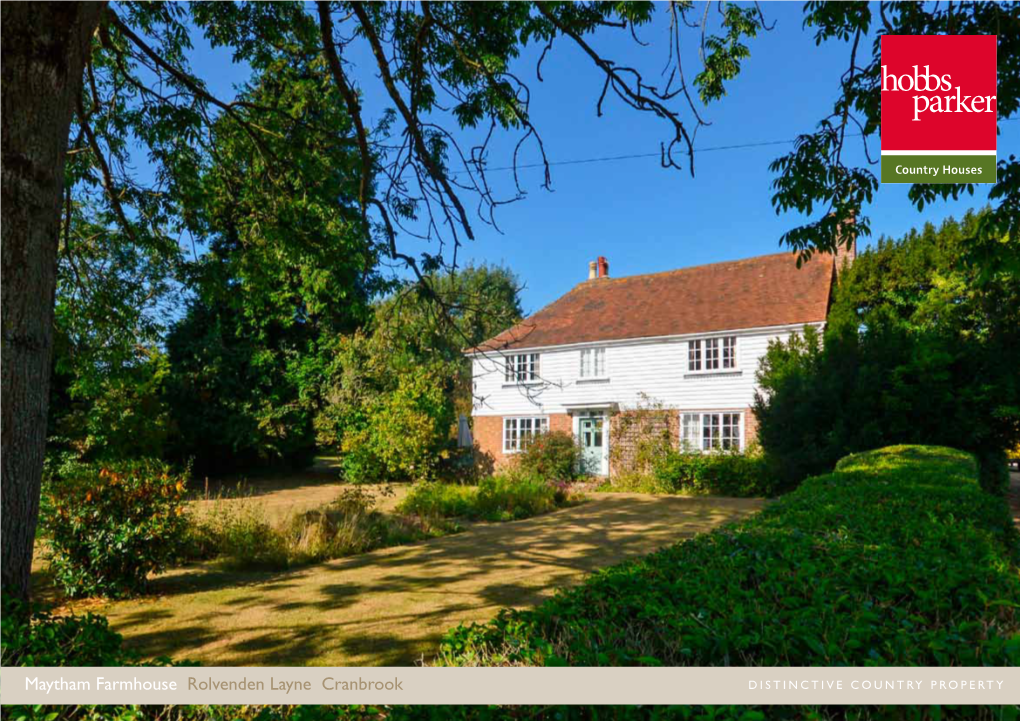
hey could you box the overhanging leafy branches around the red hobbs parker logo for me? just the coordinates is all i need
[770,2,1020,282]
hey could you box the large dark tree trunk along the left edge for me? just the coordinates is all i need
[0,2,103,599]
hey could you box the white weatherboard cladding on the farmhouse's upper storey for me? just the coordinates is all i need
[472,327,820,416]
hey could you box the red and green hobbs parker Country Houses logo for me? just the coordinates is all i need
[881,35,997,183]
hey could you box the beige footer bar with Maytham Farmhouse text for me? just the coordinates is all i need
[0,667,1020,705]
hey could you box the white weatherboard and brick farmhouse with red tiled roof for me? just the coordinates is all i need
[467,244,855,475]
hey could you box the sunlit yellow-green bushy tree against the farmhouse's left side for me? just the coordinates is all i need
[315,266,521,482]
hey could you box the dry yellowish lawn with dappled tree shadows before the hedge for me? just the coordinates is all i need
[91,494,762,666]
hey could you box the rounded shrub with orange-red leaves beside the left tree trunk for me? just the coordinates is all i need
[44,460,187,598]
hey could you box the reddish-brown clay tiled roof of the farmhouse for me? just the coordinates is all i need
[477,253,832,350]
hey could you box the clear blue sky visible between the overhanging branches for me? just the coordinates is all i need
[183,2,1020,312]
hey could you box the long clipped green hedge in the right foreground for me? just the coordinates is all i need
[438,446,1020,666]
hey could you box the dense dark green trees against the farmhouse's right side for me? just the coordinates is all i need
[755,213,1020,482]
